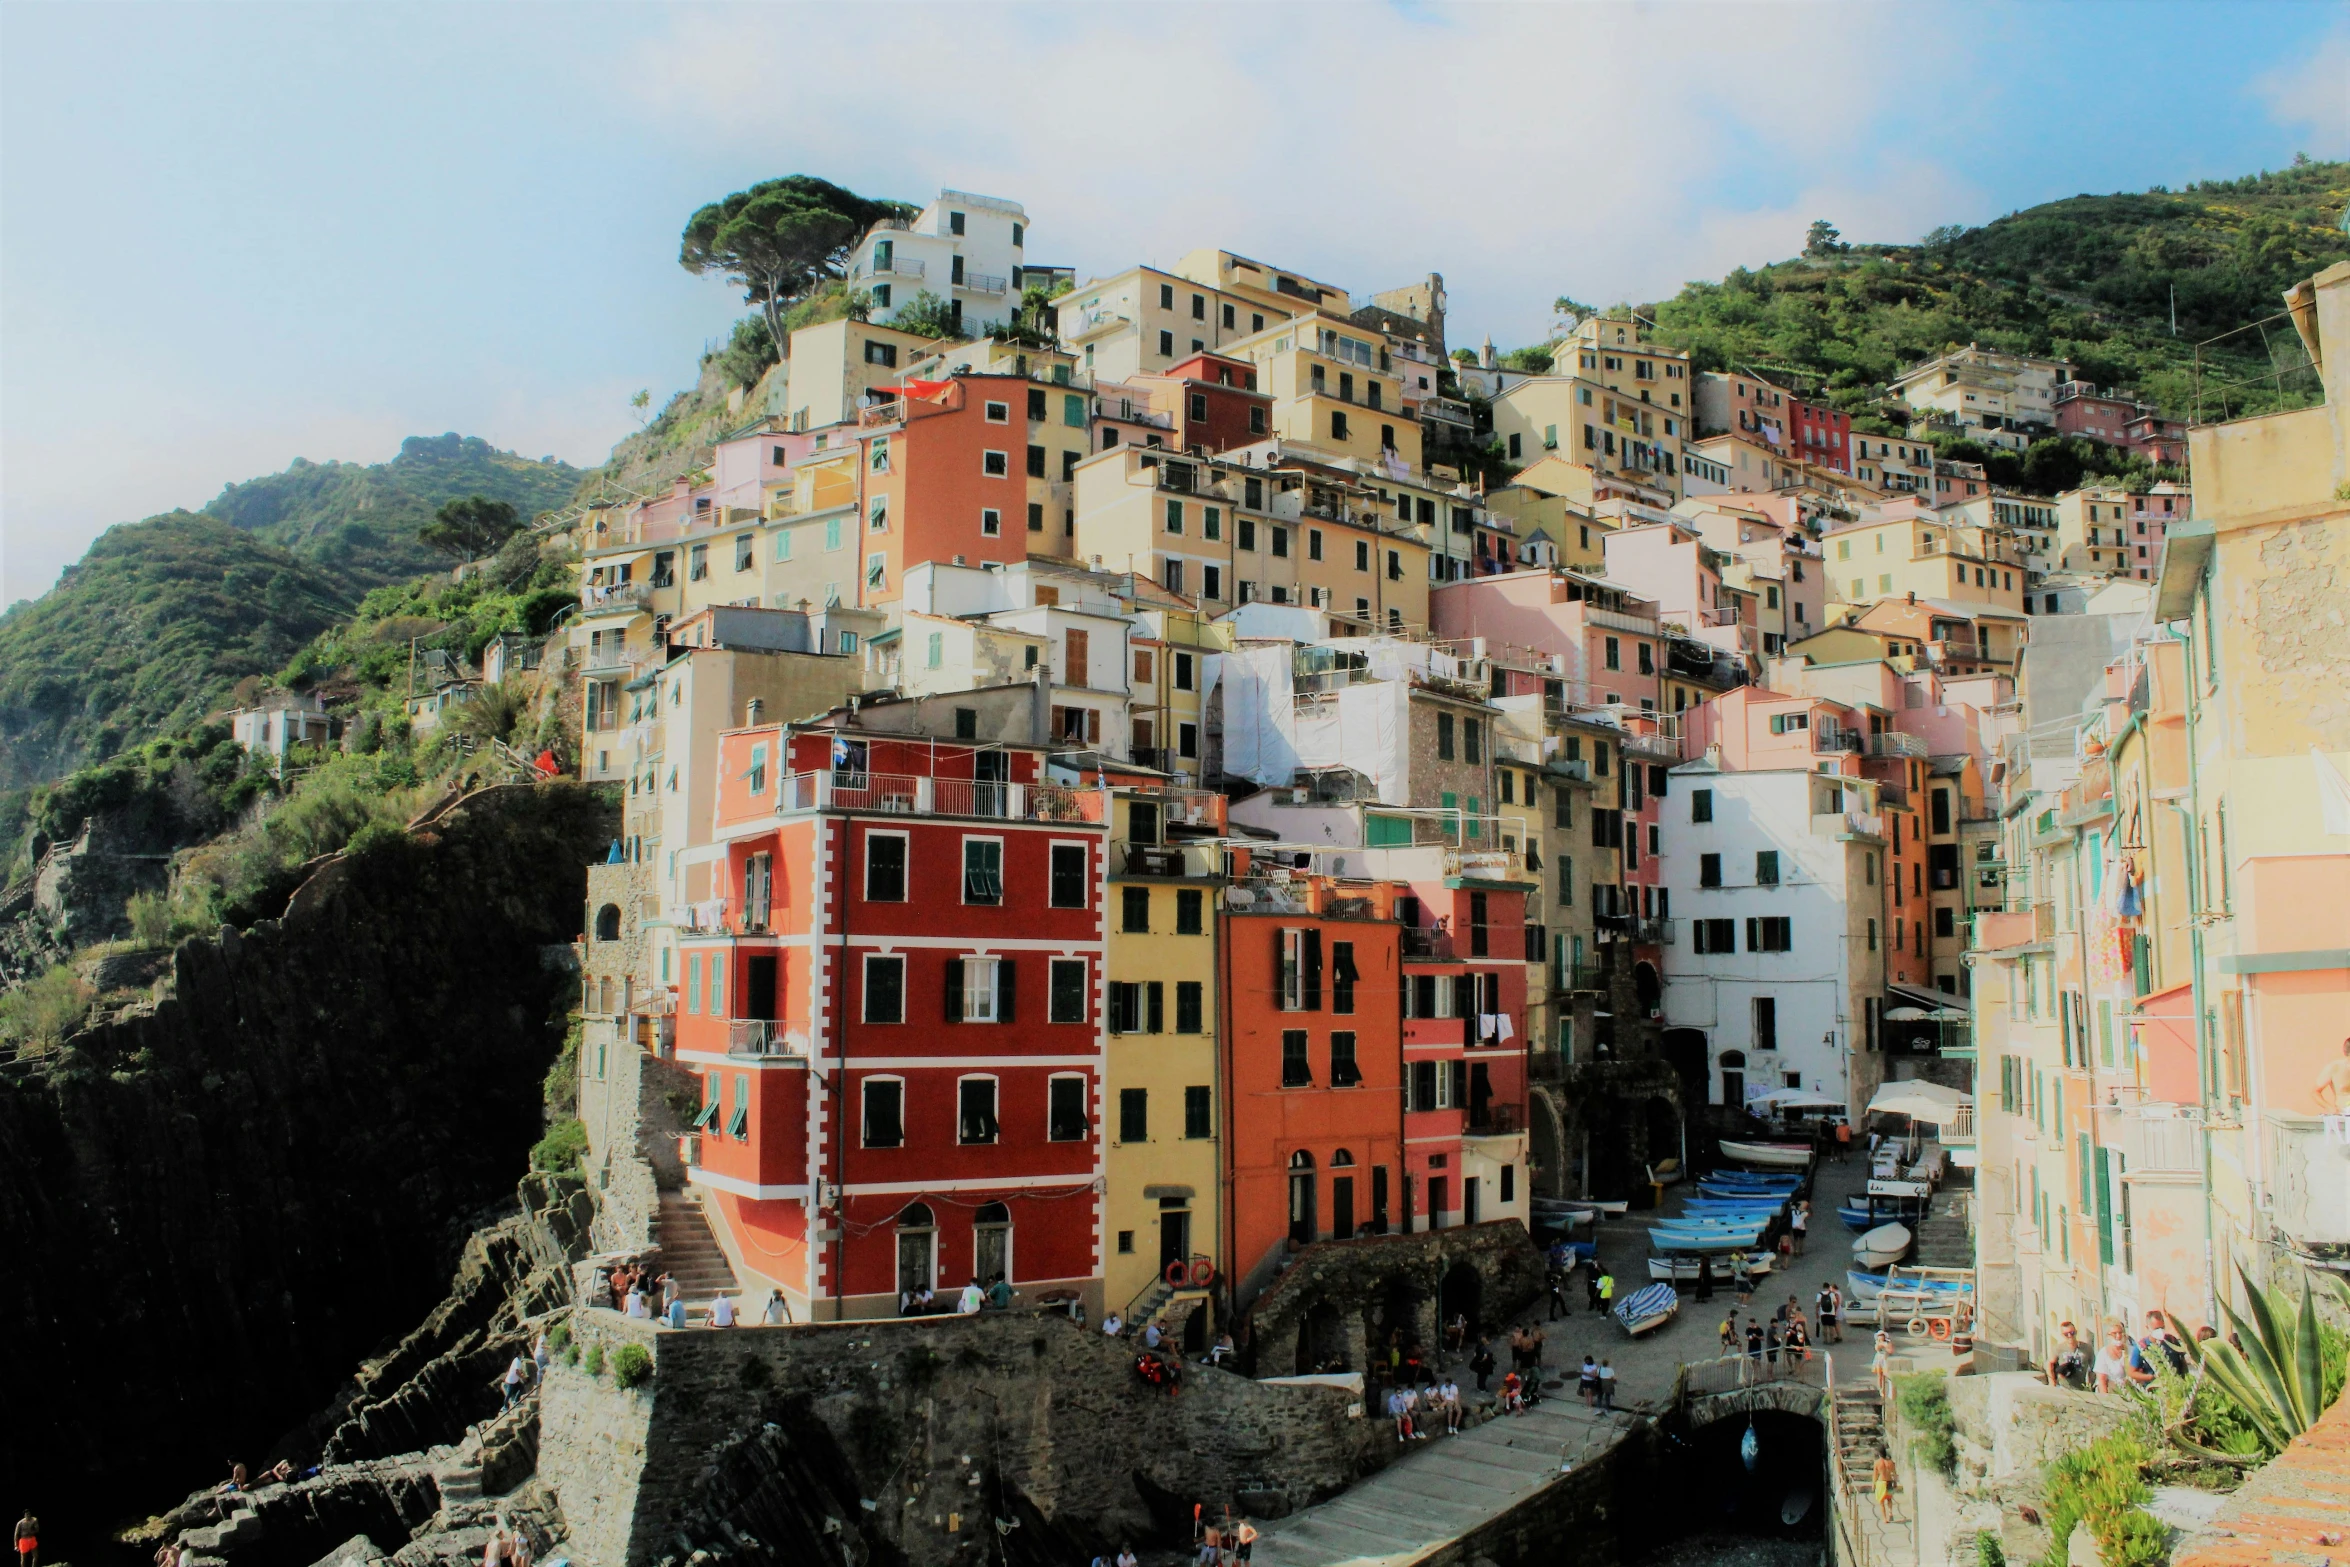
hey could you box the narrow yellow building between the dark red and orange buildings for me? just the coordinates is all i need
[1102,789,1224,1349]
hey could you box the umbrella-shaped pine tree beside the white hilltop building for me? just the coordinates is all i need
[677,174,917,359]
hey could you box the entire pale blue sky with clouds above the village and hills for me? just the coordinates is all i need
[0,0,2350,601]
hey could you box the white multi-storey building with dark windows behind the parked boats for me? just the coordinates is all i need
[1659,754,1887,1123]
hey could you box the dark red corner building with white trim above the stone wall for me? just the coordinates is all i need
[677,726,1107,1320]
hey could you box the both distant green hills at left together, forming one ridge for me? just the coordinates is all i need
[0,435,580,789]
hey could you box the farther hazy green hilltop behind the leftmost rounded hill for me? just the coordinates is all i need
[204,435,580,594]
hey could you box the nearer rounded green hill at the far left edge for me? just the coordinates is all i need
[0,512,353,787]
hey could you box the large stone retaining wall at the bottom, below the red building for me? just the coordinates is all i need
[538,1309,1394,1567]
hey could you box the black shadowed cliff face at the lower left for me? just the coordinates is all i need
[0,785,609,1560]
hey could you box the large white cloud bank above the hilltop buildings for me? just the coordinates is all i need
[616,5,1965,341]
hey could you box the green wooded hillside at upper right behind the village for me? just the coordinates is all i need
[1645,162,2350,430]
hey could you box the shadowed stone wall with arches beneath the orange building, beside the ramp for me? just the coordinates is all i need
[1246,1219,1544,1377]
